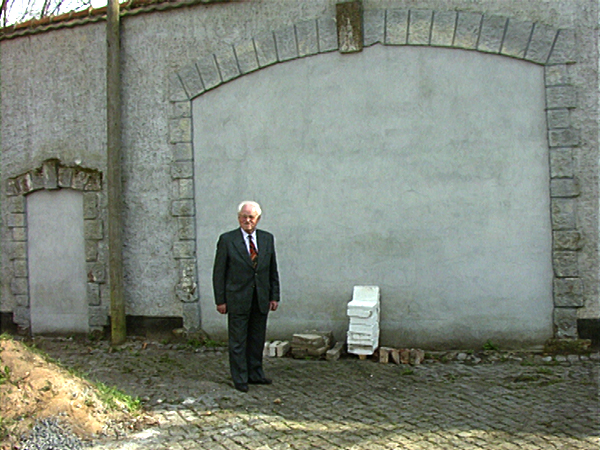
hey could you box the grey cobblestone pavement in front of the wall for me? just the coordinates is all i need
[35,341,600,450]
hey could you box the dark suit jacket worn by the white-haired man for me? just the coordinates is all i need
[213,228,279,314]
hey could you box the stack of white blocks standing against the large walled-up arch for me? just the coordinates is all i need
[347,286,380,355]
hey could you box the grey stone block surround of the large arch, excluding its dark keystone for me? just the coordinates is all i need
[169,10,583,338]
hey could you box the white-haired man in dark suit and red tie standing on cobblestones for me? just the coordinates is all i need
[213,201,279,392]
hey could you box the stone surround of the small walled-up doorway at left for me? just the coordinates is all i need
[8,159,108,332]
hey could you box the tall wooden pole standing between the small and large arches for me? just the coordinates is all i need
[106,0,127,345]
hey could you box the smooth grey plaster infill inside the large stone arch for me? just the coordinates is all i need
[193,46,552,347]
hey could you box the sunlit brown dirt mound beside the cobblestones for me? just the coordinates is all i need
[0,339,138,449]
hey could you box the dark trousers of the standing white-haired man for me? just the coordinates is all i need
[227,294,268,384]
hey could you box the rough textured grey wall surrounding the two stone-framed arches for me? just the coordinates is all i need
[0,0,600,348]
